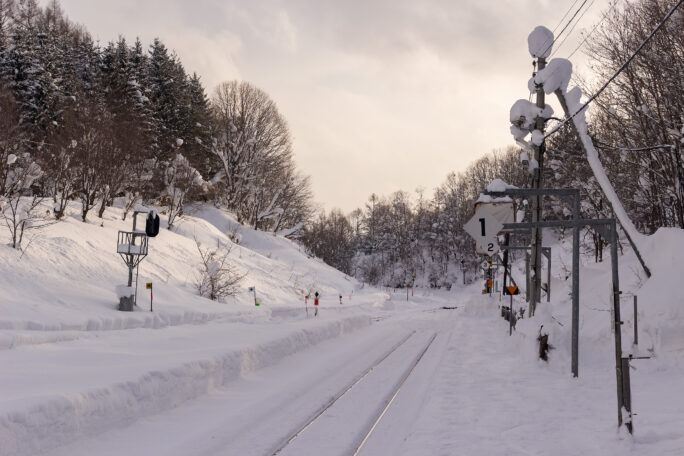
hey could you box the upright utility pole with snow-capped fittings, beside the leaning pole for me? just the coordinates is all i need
[528,57,546,317]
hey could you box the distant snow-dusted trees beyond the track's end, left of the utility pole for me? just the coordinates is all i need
[302,148,528,287]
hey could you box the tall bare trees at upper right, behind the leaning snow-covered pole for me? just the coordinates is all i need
[586,0,684,233]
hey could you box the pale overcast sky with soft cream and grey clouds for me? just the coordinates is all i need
[61,0,608,212]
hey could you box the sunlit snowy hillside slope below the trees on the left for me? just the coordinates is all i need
[0,201,374,334]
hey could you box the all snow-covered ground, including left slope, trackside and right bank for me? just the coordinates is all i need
[0,206,684,456]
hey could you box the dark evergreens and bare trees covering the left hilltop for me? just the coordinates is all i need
[0,0,312,249]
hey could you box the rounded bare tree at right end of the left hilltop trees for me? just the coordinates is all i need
[211,81,308,229]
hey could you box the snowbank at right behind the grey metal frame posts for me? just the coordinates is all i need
[514,228,684,364]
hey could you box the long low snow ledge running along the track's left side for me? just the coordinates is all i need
[0,316,371,456]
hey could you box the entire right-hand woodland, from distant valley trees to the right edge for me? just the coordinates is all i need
[303,0,684,286]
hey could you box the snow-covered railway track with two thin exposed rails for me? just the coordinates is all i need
[271,331,437,456]
